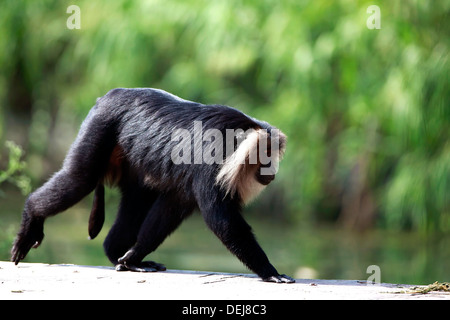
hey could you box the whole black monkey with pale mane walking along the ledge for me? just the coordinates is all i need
[11,88,295,283]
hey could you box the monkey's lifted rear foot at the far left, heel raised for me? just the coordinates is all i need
[11,214,44,265]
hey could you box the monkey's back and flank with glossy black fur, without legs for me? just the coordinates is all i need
[96,88,271,197]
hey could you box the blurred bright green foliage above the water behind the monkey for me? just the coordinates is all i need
[0,0,450,232]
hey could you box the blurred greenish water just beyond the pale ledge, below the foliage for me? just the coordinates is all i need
[0,191,450,284]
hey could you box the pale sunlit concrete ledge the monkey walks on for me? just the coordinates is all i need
[0,261,450,300]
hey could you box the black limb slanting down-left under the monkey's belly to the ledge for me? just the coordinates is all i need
[116,194,194,272]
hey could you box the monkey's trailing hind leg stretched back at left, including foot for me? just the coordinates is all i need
[11,108,115,264]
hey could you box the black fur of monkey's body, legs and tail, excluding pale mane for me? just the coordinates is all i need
[11,89,293,282]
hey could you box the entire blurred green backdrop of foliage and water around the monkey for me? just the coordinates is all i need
[0,0,450,284]
